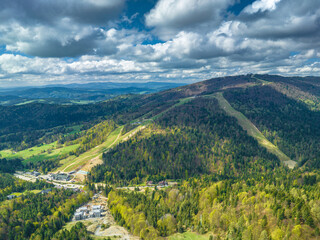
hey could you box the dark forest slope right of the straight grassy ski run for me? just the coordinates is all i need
[224,86,320,168]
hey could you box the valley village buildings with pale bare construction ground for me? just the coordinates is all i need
[7,171,177,240]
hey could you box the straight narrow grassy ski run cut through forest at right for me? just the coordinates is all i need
[214,92,297,168]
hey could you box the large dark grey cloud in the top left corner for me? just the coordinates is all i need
[0,0,125,57]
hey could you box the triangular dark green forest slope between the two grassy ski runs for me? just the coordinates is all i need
[89,98,279,183]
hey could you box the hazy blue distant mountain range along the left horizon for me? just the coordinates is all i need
[0,82,185,105]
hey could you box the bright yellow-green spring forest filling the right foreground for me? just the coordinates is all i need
[109,168,320,240]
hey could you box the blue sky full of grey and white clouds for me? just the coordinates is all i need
[0,0,320,87]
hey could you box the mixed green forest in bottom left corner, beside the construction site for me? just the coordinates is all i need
[0,174,89,240]
